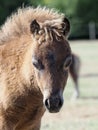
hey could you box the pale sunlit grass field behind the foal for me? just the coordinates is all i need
[41,41,98,130]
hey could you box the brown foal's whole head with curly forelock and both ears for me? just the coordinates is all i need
[30,18,71,112]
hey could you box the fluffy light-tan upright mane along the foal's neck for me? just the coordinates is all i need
[0,7,64,44]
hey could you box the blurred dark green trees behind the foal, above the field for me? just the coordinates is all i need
[0,0,98,40]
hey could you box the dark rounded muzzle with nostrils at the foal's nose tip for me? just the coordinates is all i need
[44,96,63,113]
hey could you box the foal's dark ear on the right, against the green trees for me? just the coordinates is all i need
[62,18,70,36]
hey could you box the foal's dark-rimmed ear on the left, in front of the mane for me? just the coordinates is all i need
[30,19,40,34]
